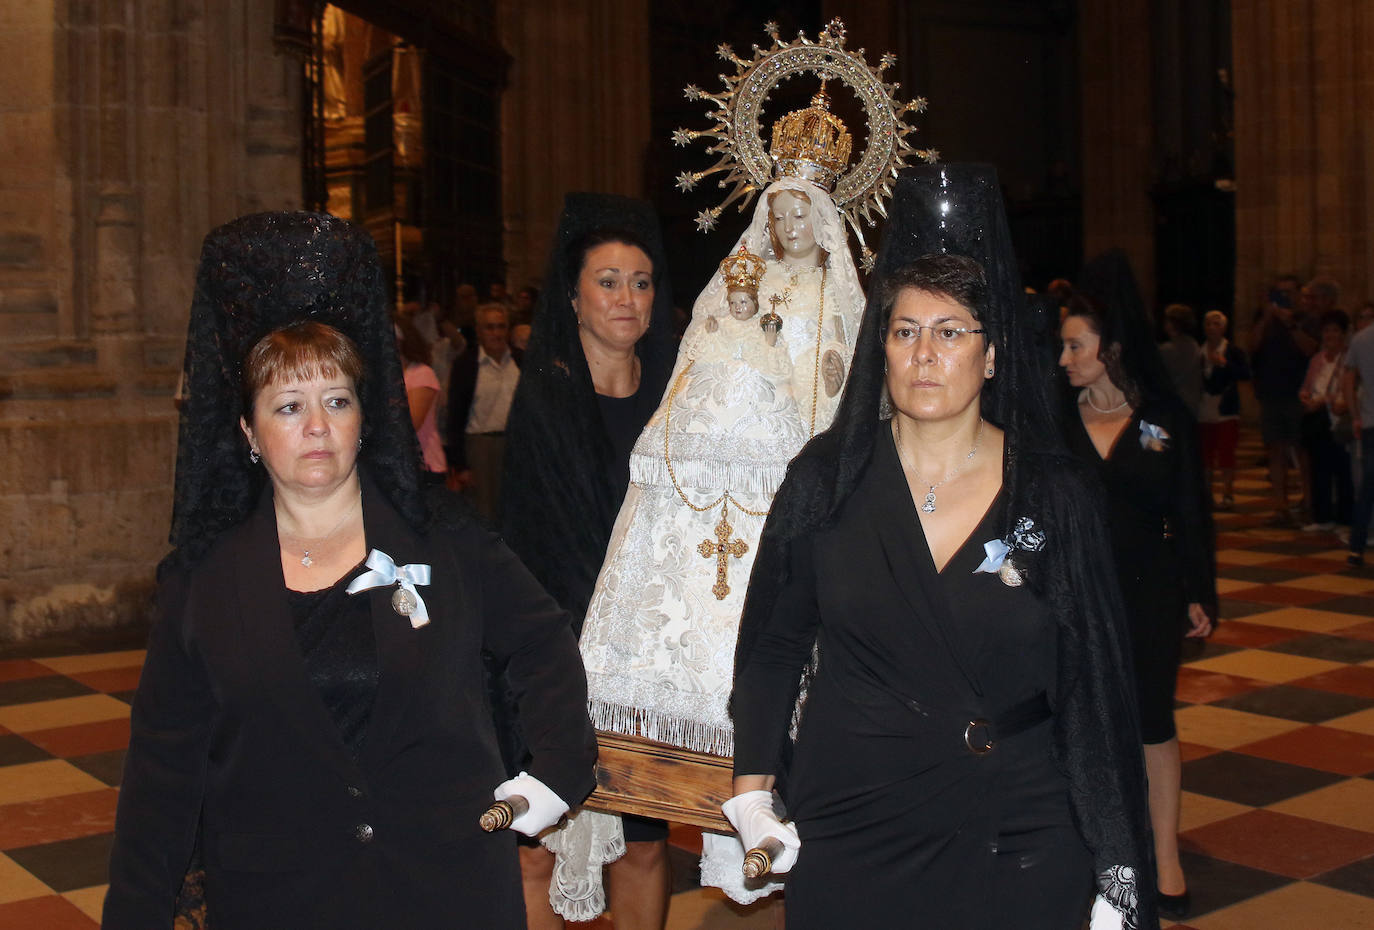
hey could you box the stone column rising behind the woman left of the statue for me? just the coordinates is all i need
[497,0,650,287]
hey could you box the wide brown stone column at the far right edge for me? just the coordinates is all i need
[1231,0,1374,313]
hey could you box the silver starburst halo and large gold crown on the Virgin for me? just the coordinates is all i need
[673,19,940,268]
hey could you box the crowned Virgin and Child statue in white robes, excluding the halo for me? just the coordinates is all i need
[581,93,864,756]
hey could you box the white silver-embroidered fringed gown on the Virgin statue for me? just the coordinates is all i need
[581,255,851,756]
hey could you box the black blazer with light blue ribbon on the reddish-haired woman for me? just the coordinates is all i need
[103,482,596,930]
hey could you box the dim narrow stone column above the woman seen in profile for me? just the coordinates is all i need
[1079,0,1154,306]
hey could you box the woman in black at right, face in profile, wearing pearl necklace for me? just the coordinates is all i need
[1059,251,1216,916]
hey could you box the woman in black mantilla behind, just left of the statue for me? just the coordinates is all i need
[502,194,676,930]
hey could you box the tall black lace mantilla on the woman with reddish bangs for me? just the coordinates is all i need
[164,213,429,567]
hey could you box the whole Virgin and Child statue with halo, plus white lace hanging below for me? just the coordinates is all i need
[544,21,933,919]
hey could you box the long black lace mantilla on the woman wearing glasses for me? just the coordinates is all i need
[735,163,1158,930]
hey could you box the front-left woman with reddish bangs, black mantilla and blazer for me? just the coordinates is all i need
[103,213,595,930]
